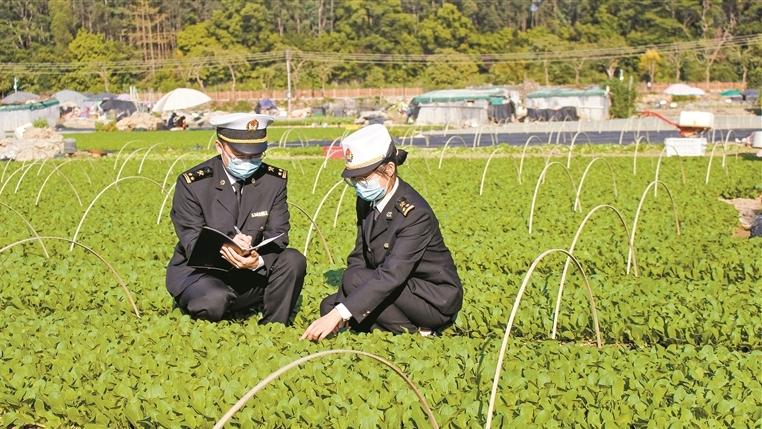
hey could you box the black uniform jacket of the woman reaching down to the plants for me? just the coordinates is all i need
[340,178,463,322]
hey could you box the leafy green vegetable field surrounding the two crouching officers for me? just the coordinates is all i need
[0,141,762,428]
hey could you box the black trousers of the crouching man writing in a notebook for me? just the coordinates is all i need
[175,249,307,325]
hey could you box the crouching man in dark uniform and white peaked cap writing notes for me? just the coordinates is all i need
[167,113,306,324]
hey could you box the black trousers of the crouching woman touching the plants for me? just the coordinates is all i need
[320,268,455,333]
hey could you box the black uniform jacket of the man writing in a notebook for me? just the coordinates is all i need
[167,156,290,296]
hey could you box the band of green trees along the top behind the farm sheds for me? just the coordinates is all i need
[0,0,762,92]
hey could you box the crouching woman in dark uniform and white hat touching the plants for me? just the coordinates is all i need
[302,125,463,341]
